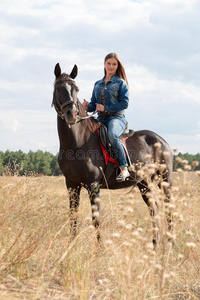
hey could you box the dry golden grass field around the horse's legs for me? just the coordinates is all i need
[0,172,200,300]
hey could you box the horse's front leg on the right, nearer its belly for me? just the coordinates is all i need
[89,184,101,242]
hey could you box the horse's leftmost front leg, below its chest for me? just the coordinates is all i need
[68,186,81,239]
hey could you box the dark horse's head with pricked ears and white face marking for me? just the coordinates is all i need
[52,63,79,125]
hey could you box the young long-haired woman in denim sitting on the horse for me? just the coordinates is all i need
[83,53,130,181]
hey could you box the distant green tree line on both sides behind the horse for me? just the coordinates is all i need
[0,150,200,176]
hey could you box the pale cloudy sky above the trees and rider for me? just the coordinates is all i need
[0,0,200,154]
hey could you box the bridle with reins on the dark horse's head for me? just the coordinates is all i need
[51,76,96,124]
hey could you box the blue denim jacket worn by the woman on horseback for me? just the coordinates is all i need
[88,74,129,114]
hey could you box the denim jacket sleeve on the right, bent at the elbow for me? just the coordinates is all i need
[105,81,129,113]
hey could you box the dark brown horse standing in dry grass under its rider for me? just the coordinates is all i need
[52,64,173,243]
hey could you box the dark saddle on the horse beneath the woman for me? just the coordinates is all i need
[99,122,134,165]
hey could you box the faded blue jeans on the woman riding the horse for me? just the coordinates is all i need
[98,114,128,168]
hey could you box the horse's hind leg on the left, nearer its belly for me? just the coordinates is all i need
[137,180,158,248]
